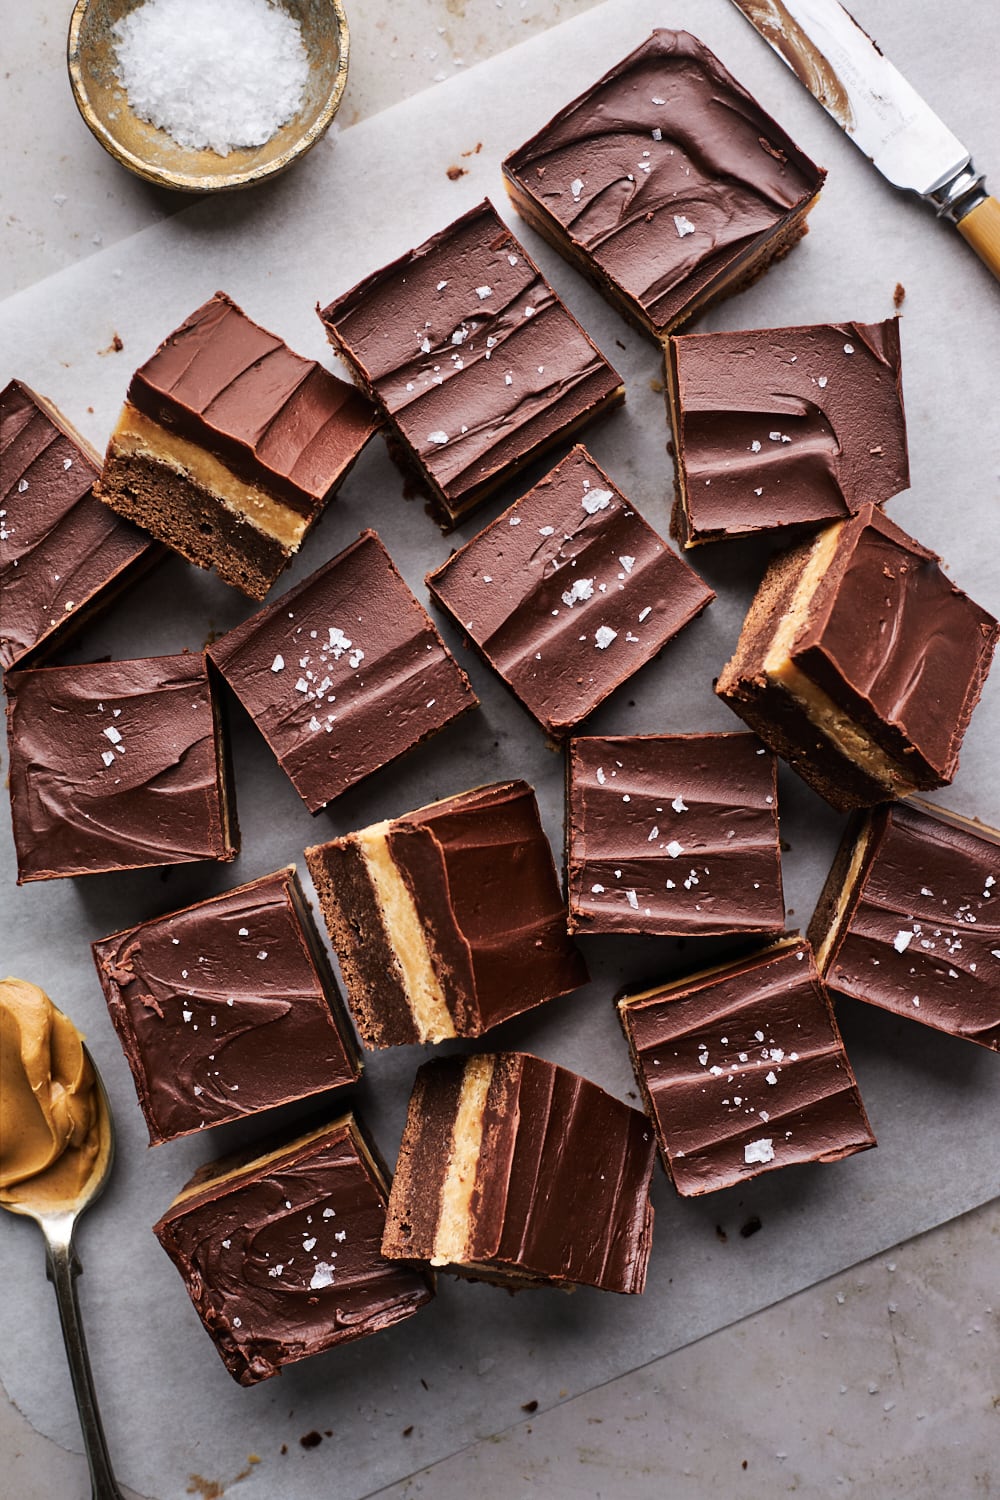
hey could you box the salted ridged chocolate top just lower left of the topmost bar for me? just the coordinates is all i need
[321,200,622,518]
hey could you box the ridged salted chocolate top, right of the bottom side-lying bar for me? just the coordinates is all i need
[619,939,876,1197]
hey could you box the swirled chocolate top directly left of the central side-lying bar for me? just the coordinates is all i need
[93,867,361,1145]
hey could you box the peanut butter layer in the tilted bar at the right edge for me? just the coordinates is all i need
[763,522,916,797]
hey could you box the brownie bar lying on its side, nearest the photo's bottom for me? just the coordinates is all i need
[382,1052,655,1293]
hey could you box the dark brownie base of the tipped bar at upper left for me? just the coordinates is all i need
[94,453,292,600]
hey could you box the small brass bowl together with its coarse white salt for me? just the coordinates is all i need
[69,0,348,192]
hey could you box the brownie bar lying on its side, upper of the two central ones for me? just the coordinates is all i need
[306,782,588,1047]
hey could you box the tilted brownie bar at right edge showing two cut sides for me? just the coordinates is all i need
[717,506,1000,809]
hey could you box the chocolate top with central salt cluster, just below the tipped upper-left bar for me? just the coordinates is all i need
[208,531,478,813]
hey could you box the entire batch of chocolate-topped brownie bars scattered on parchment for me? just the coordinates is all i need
[0,30,1000,1385]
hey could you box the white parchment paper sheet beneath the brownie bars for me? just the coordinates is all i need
[0,0,1000,1500]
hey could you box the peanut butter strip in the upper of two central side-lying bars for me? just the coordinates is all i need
[357,821,457,1043]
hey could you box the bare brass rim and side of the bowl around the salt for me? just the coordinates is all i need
[67,0,349,192]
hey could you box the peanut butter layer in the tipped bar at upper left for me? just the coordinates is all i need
[111,402,309,552]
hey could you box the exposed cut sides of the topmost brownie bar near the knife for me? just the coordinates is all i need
[504,174,819,342]
